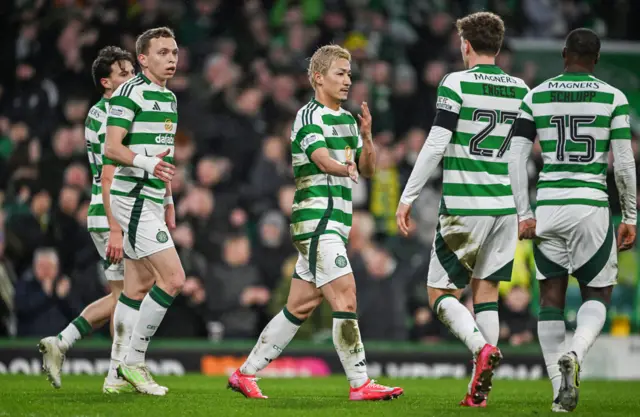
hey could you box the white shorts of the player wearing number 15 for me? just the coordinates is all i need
[533,205,618,288]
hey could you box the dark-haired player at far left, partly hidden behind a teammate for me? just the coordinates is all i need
[38,46,135,393]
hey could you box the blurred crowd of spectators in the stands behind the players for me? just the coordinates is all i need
[0,0,640,344]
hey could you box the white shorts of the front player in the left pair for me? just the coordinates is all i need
[111,195,174,259]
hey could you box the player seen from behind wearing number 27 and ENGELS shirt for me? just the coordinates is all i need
[396,12,529,407]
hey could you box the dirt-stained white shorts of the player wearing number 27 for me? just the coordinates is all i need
[427,214,518,290]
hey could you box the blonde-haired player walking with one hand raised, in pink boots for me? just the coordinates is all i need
[229,45,403,400]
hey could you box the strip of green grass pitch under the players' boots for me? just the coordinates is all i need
[0,375,640,417]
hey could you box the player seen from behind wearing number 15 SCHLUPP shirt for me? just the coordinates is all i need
[509,29,636,412]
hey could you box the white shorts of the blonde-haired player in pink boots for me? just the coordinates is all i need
[293,234,352,288]
